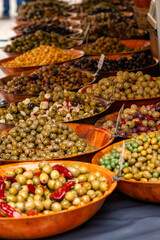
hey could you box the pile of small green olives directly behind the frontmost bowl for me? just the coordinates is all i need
[0,117,96,160]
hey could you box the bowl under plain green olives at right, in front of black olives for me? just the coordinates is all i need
[79,84,160,113]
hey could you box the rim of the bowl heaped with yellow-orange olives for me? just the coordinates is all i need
[0,48,84,72]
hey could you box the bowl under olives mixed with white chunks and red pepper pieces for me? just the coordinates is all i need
[0,95,111,131]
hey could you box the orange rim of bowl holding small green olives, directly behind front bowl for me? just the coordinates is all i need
[0,123,114,163]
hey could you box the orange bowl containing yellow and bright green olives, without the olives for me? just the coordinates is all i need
[92,139,160,203]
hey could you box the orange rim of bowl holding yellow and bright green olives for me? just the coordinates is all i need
[91,137,160,185]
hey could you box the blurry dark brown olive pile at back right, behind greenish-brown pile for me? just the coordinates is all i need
[81,12,147,42]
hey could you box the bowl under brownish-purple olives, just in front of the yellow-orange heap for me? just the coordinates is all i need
[0,69,96,103]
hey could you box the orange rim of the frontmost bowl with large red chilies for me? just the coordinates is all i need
[0,160,117,221]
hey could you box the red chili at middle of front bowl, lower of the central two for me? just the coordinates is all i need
[50,181,75,201]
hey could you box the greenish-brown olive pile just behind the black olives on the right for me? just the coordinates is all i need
[84,37,133,55]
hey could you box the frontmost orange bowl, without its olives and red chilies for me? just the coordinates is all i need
[0,161,117,239]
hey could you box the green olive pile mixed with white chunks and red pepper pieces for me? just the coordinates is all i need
[0,86,106,124]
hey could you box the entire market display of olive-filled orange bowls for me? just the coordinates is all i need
[0,0,160,237]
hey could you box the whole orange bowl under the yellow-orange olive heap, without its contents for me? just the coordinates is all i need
[0,49,84,75]
